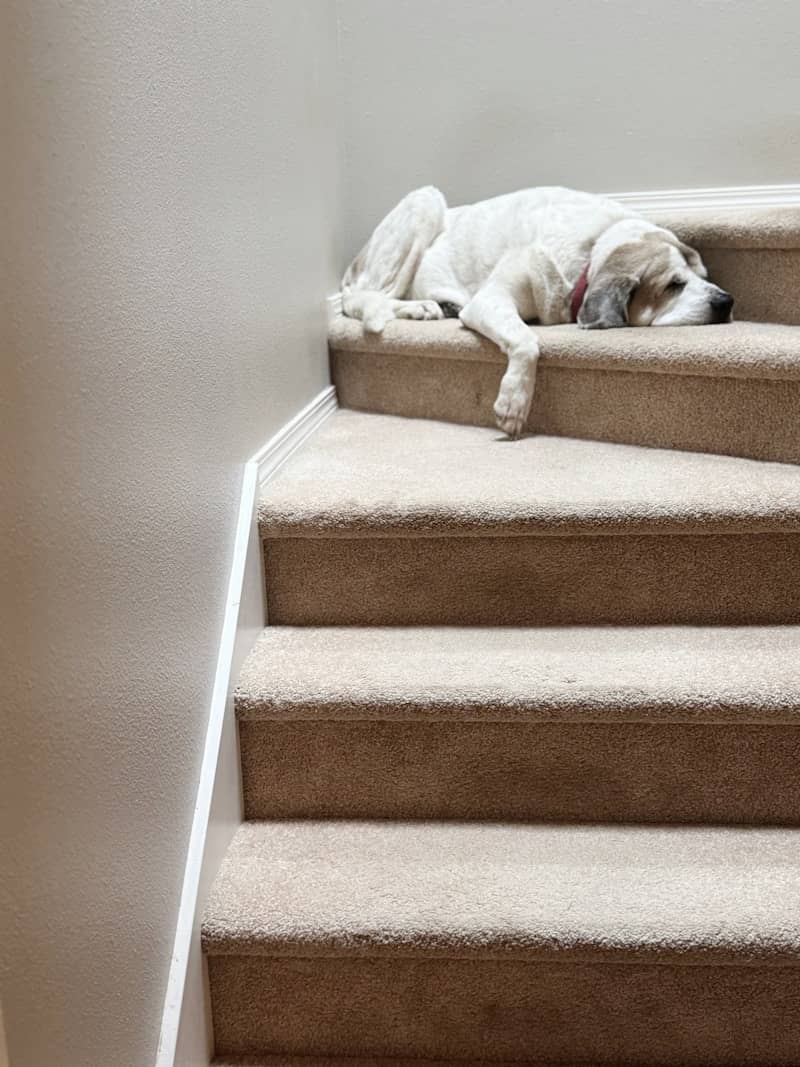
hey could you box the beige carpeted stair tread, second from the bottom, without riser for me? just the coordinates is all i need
[236,626,800,724]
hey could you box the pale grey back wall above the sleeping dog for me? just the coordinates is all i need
[338,0,800,255]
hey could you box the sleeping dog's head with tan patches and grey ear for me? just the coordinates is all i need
[578,225,733,330]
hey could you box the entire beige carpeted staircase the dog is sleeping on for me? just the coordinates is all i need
[204,210,800,1067]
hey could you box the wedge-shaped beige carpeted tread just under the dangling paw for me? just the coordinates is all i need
[259,411,800,537]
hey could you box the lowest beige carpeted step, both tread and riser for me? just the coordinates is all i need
[203,821,800,1067]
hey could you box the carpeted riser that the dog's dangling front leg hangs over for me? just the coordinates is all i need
[332,350,800,463]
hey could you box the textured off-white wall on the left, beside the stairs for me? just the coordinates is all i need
[0,0,337,1067]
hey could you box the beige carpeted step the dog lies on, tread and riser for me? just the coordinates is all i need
[330,311,800,463]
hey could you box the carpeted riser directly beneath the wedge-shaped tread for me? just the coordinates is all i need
[265,534,800,625]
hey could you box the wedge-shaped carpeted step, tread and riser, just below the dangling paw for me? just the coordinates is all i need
[259,412,800,625]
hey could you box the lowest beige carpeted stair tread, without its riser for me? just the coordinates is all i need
[203,821,800,966]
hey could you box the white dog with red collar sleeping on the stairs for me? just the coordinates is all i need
[341,186,734,439]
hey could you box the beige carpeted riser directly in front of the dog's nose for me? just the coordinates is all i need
[701,248,800,325]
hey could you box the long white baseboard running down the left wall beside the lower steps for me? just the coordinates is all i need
[156,385,337,1067]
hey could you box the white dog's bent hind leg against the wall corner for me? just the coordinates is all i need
[341,186,447,333]
